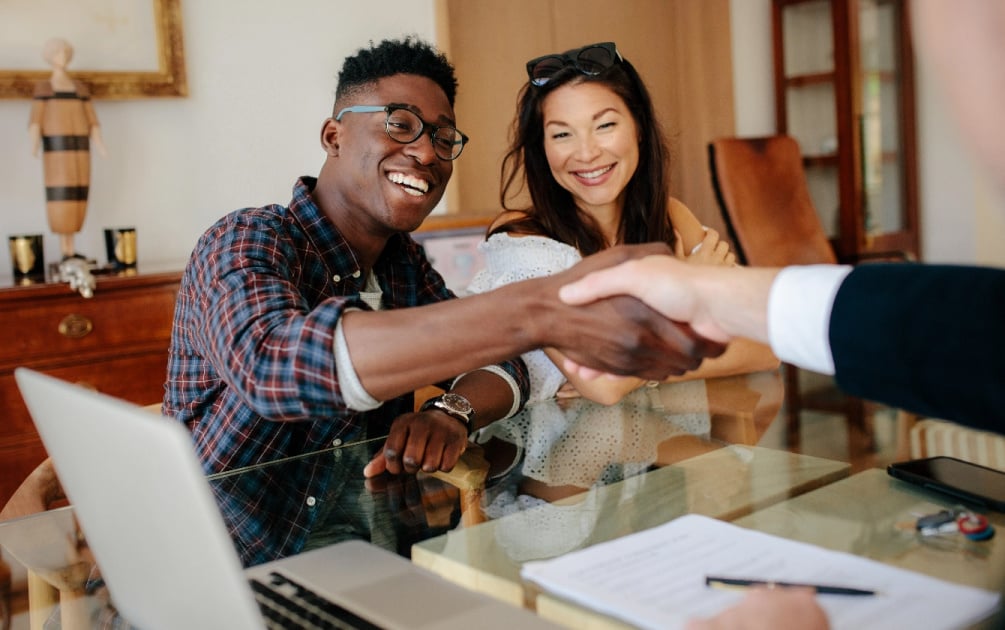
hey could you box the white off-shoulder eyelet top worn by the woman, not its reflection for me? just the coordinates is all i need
[467,234,583,403]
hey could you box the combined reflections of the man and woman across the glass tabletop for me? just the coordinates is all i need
[209,373,781,566]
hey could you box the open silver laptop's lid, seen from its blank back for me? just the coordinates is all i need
[14,368,263,629]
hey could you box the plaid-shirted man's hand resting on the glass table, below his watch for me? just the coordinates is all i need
[363,409,467,477]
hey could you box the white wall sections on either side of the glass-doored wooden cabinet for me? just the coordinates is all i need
[730,0,1005,266]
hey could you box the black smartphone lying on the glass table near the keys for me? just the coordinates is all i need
[886,456,1005,512]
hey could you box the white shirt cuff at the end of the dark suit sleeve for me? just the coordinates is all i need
[768,264,851,374]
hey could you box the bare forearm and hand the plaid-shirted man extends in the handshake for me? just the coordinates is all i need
[343,243,724,400]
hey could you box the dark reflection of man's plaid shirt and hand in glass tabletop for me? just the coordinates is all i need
[209,439,459,566]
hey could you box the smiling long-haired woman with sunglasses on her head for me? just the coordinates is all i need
[469,35,778,404]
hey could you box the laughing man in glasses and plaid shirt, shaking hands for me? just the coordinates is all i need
[163,39,722,562]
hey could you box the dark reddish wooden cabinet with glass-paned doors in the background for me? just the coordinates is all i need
[773,0,920,260]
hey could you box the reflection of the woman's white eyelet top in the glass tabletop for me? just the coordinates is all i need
[476,380,712,562]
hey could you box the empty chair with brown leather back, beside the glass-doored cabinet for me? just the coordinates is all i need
[709,136,903,449]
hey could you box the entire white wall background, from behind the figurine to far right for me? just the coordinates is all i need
[0,0,1005,273]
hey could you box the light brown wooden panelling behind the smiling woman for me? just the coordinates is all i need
[436,0,735,234]
